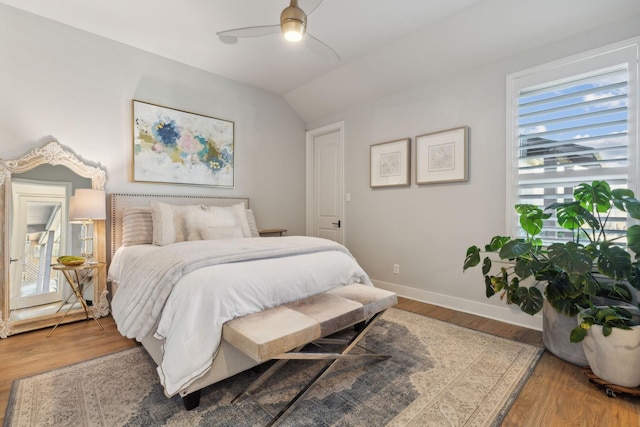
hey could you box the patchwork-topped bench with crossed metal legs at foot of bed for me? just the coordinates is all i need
[178,284,397,414]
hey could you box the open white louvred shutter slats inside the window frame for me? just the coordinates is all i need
[518,64,629,241]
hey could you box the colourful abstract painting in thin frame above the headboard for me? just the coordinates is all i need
[132,99,235,188]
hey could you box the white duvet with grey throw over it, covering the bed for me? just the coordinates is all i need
[109,236,371,396]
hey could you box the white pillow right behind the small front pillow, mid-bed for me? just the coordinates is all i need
[184,203,251,240]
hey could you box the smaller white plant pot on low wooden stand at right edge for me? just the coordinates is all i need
[582,310,640,388]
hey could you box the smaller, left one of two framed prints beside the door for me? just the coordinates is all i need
[369,138,411,188]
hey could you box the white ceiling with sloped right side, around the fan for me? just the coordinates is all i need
[0,0,640,121]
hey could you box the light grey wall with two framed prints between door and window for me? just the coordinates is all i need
[308,15,640,328]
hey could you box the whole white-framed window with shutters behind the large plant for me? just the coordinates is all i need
[507,41,640,243]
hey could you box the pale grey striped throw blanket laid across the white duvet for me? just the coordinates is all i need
[112,236,360,341]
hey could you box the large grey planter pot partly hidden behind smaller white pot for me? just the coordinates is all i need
[542,299,589,366]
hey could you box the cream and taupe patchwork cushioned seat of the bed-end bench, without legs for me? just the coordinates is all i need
[222,284,397,362]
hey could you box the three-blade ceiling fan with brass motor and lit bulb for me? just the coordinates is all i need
[216,0,340,62]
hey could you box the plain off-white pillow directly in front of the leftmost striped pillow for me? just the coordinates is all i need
[150,202,206,246]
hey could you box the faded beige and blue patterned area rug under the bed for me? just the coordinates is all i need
[5,309,543,427]
